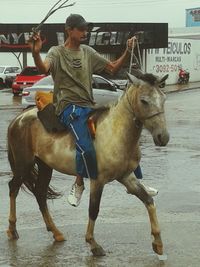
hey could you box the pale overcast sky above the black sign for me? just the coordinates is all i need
[0,0,200,28]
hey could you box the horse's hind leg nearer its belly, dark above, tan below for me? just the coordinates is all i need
[34,159,65,242]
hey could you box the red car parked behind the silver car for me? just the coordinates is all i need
[12,67,46,96]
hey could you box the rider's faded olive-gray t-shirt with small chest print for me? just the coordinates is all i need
[46,45,109,115]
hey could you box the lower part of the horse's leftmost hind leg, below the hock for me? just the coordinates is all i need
[7,176,22,239]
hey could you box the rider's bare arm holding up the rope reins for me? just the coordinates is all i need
[105,36,136,74]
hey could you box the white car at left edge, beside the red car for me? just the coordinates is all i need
[0,66,21,87]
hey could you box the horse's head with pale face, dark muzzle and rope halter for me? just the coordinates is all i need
[126,71,169,146]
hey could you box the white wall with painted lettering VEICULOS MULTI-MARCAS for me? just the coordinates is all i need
[146,38,200,84]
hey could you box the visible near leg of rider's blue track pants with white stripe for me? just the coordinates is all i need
[59,104,97,179]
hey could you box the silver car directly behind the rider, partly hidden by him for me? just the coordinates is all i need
[22,75,123,108]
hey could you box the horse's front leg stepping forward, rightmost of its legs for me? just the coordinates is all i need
[119,174,163,255]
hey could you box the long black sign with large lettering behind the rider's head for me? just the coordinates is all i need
[0,23,168,53]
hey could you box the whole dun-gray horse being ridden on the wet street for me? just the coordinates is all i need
[7,72,169,256]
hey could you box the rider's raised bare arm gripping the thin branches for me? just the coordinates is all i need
[29,33,50,74]
